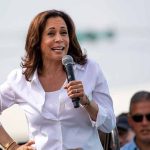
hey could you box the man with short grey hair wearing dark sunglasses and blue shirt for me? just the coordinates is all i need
[121,91,150,150]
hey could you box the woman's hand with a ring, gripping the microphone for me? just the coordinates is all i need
[64,80,87,104]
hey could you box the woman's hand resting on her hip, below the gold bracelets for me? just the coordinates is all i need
[15,140,35,150]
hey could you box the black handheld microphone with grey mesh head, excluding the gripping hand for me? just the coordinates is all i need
[62,55,80,108]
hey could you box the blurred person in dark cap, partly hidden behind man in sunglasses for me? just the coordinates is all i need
[116,113,134,147]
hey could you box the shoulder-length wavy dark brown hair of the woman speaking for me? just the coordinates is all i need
[21,10,87,81]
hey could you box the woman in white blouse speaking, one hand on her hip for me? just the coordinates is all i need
[0,10,115,150]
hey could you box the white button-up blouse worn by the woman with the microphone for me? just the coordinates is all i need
[0,59,116,150]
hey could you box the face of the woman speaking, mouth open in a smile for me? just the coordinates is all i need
[41,17,69,61]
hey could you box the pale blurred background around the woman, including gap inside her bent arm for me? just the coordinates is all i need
[0,0,150,141]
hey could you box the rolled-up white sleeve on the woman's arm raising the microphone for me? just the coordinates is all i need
[92,64,116,133]
